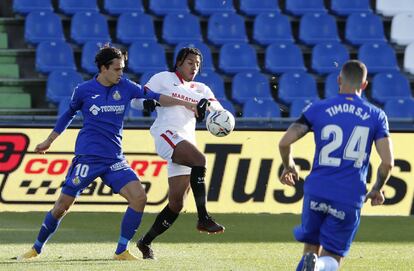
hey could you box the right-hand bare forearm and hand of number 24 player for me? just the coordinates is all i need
[365,137,394,206]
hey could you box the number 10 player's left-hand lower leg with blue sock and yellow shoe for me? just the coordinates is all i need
[17,193,75,261]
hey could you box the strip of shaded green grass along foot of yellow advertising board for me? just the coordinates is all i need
[0,212,414,244]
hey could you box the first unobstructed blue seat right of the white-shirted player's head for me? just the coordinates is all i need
[219,43,259,74]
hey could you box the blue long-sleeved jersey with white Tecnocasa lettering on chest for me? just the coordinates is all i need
[54,77,160,158]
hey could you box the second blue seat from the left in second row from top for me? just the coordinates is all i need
[70,12,111,45]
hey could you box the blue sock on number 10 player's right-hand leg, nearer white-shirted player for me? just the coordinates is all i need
[115,207,142,254]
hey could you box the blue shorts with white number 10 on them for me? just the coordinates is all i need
[62,155,139,197]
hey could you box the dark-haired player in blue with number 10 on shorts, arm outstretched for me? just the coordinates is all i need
[17,45,197,260]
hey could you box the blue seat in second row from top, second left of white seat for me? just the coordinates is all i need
[299,13,339,45]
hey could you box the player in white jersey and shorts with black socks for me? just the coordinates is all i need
[131,47,224,259]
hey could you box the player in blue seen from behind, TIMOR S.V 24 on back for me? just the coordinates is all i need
[279,60,394,271]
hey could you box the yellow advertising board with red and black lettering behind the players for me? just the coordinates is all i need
[0,128,414,216]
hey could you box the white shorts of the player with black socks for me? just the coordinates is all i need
[152,130,194,177]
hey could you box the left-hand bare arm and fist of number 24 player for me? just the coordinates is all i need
[279,122,309,186]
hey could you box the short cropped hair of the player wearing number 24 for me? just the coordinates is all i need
[341,60,368,87]
